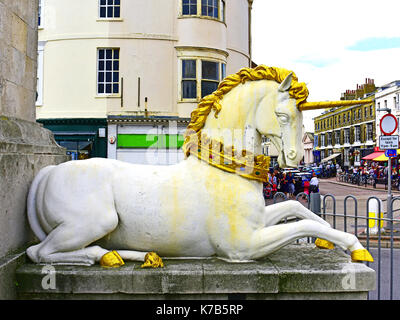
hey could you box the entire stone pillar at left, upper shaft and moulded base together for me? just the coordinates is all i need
[0,0,69,299]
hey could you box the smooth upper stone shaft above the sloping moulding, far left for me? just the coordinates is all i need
[0,0,38,121]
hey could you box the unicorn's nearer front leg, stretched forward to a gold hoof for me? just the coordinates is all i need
[249,219,373,261]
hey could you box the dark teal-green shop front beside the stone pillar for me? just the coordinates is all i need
[37,118,107,160]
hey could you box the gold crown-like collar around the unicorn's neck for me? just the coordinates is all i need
[186,132,270,182]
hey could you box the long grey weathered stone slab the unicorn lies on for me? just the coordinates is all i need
[16,244,375,299]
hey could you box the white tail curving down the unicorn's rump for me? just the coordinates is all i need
[27,166,55,241]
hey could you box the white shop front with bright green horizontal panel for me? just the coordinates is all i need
[107,116,190,165]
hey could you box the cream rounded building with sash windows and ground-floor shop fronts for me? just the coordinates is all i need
[37,0,252,164]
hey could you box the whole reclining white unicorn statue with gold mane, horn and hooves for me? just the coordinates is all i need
[27,65,373,267]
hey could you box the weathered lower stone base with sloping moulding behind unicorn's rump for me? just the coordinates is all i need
[0,115,70,299]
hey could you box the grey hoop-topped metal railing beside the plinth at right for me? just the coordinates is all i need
[273,192,400,300]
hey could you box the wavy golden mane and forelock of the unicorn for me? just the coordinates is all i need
[183,65,308,154]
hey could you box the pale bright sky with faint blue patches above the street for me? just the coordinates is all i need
[252,0,400,132]
